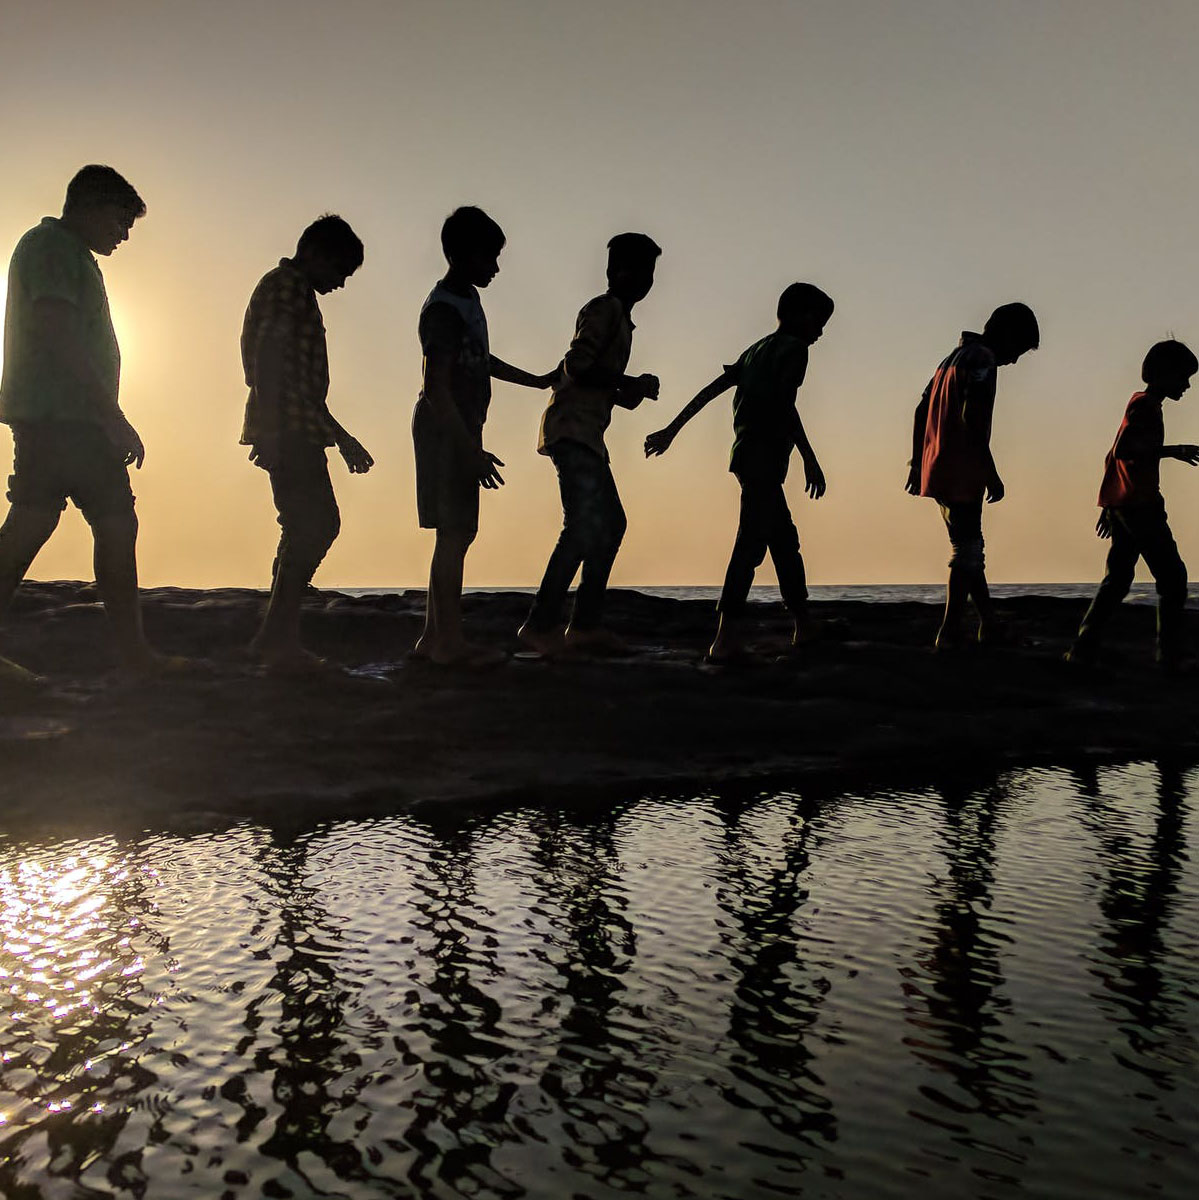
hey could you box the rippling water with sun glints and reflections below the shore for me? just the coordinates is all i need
[0,764,1199,1200]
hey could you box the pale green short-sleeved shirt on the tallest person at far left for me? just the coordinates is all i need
[0,217,121,425]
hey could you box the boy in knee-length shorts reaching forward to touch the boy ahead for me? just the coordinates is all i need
[412,206,553,667]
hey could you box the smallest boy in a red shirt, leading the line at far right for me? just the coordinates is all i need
[1066,341,1199,670]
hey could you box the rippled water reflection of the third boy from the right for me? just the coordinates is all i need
[717,798,837,1163]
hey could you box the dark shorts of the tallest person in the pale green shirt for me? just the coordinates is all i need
[8,421,133,522]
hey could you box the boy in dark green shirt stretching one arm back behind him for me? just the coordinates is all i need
[646,283,833,662]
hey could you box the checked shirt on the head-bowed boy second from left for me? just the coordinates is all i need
[241,258,335,446]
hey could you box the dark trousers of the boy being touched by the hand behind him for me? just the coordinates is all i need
[528,439,628,631]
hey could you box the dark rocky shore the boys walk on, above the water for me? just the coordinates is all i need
[0,583,1199,830]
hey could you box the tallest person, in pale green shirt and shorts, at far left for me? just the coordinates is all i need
[0,166,172,678]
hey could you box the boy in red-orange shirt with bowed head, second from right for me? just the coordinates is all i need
[905,304,1041,650]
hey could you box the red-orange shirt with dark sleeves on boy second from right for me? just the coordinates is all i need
[921,332,996,504]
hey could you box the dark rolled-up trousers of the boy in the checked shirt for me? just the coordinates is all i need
[270,440,341,582]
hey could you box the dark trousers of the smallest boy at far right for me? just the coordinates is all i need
[1075,497,1187,662]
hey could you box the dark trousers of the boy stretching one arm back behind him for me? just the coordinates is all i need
[717,472,808,617]
